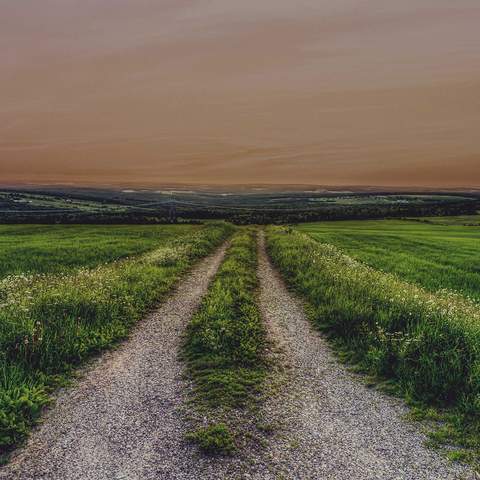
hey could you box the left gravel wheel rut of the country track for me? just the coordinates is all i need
[0,247,232,480]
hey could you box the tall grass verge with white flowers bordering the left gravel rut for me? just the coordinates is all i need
[0,224,232,460]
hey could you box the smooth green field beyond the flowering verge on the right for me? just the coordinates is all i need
[298,217,480,300]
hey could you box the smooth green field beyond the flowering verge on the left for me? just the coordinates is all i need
[0,225,198,278]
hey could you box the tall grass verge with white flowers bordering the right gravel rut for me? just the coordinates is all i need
[267,227,480,465]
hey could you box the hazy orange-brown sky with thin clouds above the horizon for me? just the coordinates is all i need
[0,0,480,187]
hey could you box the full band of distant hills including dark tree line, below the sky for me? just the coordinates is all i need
[0,186,480,225]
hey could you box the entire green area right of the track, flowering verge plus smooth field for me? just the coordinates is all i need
[267,222,480,462]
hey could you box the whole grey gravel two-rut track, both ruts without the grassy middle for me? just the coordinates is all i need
[0,234,475,480]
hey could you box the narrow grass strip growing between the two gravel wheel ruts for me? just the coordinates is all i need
[184,229,266,453]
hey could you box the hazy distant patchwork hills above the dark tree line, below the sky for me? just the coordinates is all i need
[0,189,472,213]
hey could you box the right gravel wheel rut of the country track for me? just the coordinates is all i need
[259,231,475,480]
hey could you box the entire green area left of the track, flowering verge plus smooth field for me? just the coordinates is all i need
[0,223,233,459]
